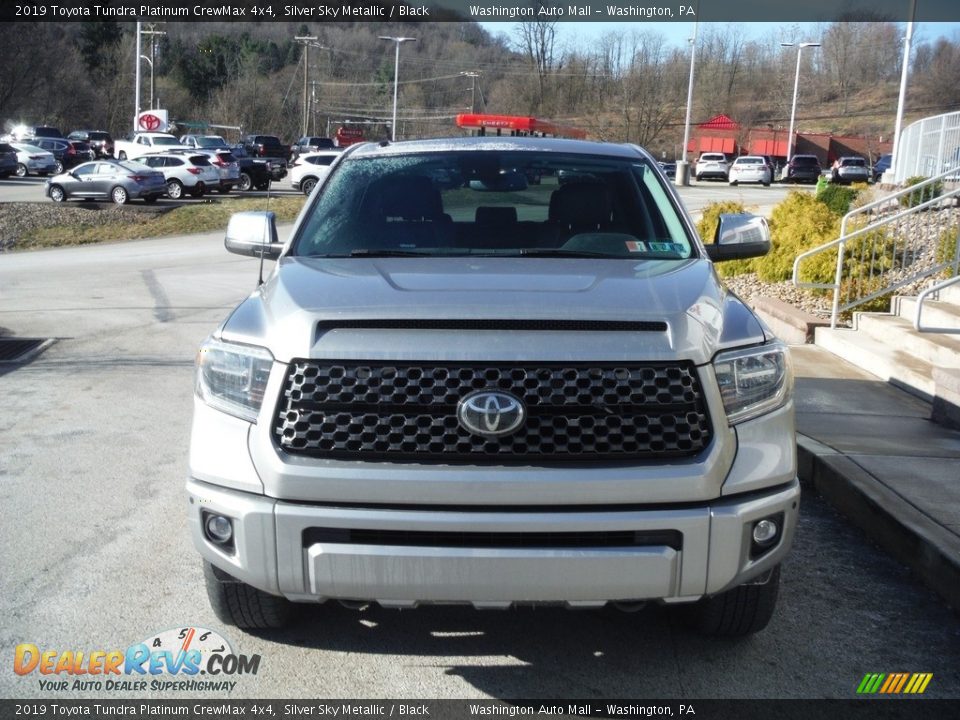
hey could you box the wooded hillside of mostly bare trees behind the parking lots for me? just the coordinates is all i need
[0,22,960,157]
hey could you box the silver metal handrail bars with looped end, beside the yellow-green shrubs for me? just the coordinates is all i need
[792,167,960,327]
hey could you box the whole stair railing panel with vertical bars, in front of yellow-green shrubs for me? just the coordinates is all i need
[793,166,960,327]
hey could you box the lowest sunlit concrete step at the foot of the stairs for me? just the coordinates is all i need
[814,328,936,402]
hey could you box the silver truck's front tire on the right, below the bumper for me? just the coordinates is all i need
[688,565,780,637]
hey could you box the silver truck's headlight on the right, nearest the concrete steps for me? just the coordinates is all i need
[713,342,793,425]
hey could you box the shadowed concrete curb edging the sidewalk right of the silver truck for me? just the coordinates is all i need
[797,434,960,612]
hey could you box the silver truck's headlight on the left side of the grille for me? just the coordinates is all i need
[196,338,273,422]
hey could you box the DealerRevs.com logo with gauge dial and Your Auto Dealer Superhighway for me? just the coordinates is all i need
[13,627,260,692]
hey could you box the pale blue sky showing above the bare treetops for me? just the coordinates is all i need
[480,22,960,47]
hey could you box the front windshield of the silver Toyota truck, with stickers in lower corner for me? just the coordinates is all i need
[290,150,696,260]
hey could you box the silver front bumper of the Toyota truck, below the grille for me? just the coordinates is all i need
[187,479,800,607]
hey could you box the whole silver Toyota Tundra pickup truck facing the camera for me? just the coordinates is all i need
[187,137,800,635]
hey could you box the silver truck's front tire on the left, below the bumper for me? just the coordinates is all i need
[203,562,293,630]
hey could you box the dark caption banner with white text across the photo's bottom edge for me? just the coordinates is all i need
[0,697,958,720]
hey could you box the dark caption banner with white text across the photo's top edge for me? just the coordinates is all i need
[0,0,960,22]
